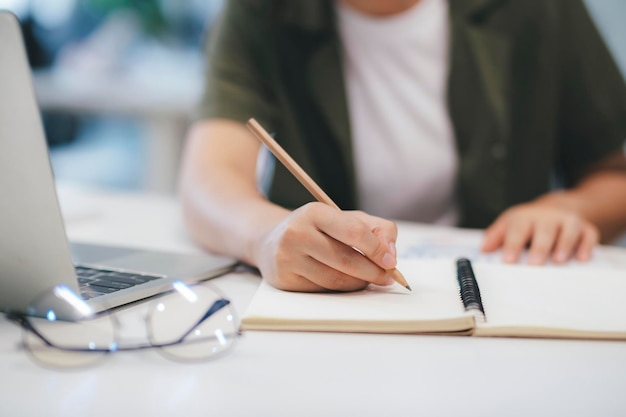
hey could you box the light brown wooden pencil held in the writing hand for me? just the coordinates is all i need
[246,118,411,290]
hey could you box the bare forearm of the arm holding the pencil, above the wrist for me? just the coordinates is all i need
[180,118,289,265]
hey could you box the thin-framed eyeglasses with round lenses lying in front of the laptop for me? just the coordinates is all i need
[6,281,241,368]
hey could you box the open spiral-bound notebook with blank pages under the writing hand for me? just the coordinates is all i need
[242,258,626,340]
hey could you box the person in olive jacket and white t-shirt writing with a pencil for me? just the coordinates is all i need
[176,0,626,291]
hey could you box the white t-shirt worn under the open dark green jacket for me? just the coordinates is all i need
[337,0,458,225]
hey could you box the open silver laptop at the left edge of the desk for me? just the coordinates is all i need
[0,11,236,312]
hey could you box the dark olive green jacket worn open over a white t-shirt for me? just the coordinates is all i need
[199,0,626,227]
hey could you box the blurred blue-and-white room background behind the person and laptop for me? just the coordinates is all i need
[0,0,626,193]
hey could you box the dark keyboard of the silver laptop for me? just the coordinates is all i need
[76,265,163,300]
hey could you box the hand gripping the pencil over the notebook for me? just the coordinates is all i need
[255,202,397,292]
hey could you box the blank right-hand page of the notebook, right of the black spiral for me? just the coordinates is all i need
[474,263,626,332]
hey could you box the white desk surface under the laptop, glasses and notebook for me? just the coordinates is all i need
[0,186,626,417]
